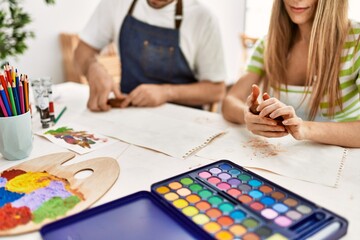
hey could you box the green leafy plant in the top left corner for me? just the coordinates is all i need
[0,0,55,62]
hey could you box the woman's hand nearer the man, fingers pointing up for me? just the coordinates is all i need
[244,84,288,138]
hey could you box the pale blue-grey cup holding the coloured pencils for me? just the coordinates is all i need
[0,111,33,160]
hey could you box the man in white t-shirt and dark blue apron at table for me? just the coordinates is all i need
[75,0,226,111]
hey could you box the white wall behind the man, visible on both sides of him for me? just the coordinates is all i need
[9,0,245,83]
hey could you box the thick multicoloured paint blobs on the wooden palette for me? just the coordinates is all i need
[0,169,84,231]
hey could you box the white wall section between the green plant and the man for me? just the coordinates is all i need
[9,0,99,83]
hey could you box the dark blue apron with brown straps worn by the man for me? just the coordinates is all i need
[119,0,197,93]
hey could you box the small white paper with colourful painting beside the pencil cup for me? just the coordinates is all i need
[38,124,116,154]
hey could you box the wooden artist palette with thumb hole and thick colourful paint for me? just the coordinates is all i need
[0,152,120,236]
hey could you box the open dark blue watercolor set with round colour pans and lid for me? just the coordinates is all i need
[41,160,348,240]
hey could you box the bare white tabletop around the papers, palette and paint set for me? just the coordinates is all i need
[0,83,360,240]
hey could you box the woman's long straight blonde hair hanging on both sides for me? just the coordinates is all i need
[264,0,349,119]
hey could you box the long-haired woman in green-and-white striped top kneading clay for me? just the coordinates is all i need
[222,0,360,147]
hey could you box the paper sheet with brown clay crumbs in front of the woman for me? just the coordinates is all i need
[196,127,346,187]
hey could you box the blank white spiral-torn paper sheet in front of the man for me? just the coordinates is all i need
[79,108,224,158]
